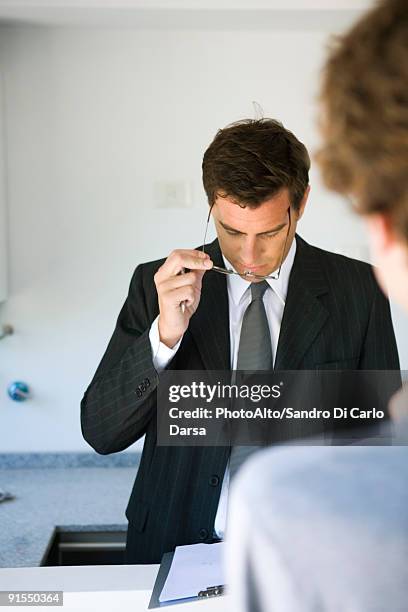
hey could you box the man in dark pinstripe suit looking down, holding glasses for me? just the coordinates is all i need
[81,118,399,563]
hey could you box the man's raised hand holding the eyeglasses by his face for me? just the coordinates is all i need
[154,249,213,348]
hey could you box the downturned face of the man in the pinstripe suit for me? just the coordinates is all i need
[212,188,309,276]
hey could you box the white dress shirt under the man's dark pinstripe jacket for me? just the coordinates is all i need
[149,240,296,538]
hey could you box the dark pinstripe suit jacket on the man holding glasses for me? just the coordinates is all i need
[81,236,399,563]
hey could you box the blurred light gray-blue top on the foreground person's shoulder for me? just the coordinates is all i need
[226,389,408,612]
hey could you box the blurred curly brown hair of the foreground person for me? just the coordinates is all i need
[316,0,408,241]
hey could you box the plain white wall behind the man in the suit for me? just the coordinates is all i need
[0,26,408,451]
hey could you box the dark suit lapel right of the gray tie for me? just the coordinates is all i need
[275,236,329,370]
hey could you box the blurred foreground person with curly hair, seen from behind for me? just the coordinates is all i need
[227,0,408,612]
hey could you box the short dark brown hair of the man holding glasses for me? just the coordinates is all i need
[202,118,310,209]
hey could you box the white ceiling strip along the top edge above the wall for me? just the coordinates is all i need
[0,0,372,30]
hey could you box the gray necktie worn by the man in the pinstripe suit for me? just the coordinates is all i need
[230,280,273,479]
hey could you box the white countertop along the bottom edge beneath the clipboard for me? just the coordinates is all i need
[0,565,228,612]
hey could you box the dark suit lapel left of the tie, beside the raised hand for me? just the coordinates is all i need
[188,240,230,370]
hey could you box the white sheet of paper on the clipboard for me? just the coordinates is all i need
[159,542,225,602]
